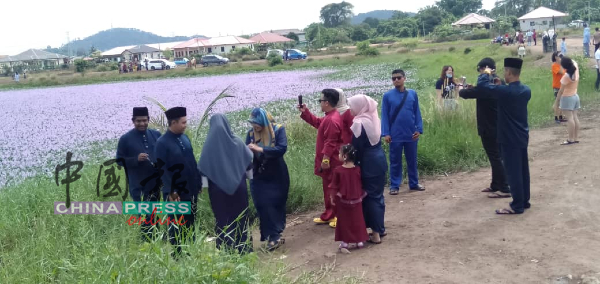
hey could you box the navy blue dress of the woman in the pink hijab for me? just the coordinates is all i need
[352,127,387,234]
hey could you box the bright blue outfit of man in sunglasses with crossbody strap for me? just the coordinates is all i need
[381,86,423,189]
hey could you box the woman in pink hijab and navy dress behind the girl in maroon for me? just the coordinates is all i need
[348,95,387,244]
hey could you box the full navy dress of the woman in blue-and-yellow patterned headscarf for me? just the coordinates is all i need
[246,126,290,242]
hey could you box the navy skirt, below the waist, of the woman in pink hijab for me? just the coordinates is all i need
[362,174,385,234]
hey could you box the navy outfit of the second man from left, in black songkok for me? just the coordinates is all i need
[155,130,202,252]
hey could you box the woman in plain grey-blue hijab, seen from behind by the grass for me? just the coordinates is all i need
[198,113,252,253]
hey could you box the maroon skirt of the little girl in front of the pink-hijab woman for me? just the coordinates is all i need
[335,196,369,243]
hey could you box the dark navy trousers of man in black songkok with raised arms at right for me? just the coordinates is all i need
[500,144,531,213]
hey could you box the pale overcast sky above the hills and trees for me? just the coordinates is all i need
[0,0,495,55]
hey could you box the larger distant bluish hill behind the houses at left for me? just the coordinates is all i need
[48,28,199,55]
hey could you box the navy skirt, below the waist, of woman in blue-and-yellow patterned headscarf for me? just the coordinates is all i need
[250,178,290,242]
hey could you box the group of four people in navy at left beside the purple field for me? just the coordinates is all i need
[116,107,289,258]
